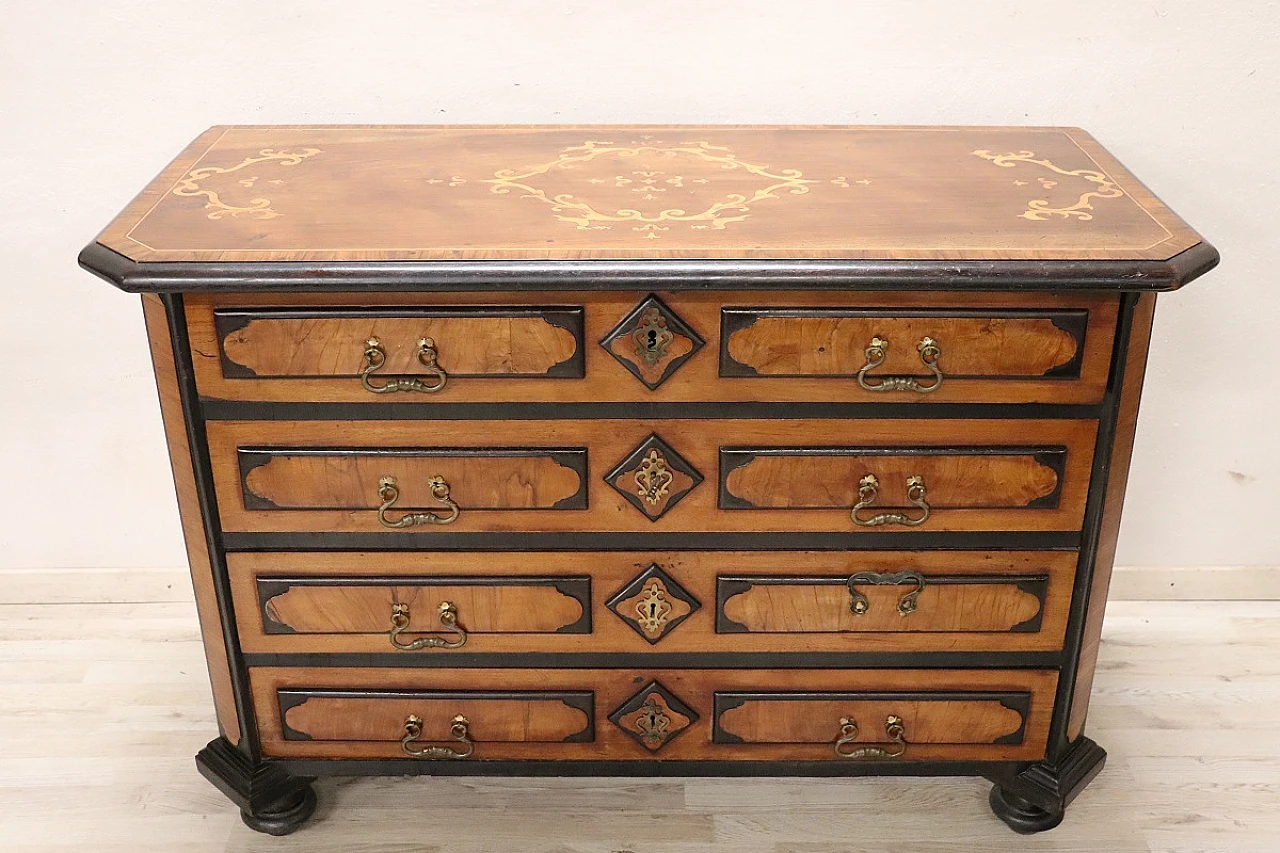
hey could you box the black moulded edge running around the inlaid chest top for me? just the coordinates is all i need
[78,242,1219,293]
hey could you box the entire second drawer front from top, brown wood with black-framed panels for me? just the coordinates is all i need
[207,419,1097,532]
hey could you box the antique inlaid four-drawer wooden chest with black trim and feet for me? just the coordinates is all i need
[81,127,1217,834]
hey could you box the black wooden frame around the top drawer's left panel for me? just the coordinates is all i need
[214,305,586,380]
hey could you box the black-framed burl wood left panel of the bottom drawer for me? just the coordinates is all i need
[276,689,595,743]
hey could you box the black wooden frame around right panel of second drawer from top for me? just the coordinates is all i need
[718,444,1068,512]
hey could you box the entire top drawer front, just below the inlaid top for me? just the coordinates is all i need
[186,291,1117,405]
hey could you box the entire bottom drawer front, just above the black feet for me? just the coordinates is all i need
[250,667,1057,762]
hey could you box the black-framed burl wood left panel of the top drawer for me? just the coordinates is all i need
[214,305,584,376]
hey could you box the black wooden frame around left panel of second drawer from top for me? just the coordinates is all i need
[236,444,588,512]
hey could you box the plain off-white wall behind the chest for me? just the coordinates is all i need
[0,0,1280,567]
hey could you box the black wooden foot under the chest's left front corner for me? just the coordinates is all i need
[196,738,316,835]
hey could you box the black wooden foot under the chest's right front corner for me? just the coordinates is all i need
[989,738,1107,834]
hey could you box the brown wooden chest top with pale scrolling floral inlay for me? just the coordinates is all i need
[85,126,1202,289]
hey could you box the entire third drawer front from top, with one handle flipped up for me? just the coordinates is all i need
[227,551,1076,653]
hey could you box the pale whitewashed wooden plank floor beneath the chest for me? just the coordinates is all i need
[0,571,1280,853]
